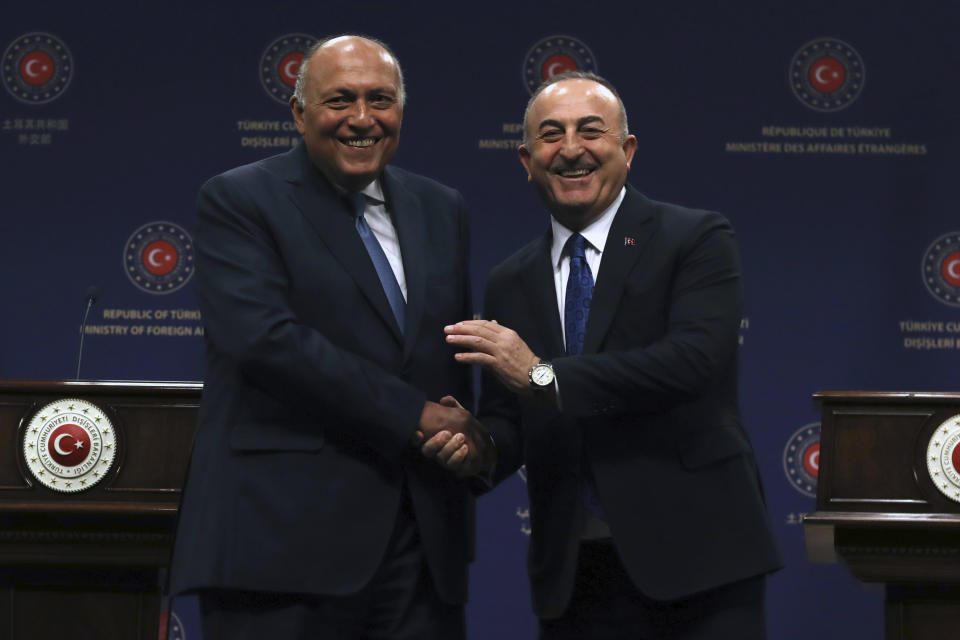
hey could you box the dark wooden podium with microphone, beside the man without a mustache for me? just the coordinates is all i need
[0,381,202,640]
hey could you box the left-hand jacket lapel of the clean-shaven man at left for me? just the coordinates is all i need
[287,143,402,341]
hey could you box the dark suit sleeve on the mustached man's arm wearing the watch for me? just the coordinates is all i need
[553,214,741,417]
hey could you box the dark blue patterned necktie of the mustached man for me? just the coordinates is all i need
[563,233,606,520]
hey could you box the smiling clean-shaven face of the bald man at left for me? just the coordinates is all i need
[290,36,403,191]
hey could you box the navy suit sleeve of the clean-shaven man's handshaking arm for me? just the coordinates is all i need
[196,170,426,459]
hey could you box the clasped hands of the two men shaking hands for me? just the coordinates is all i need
[412,396,497,478]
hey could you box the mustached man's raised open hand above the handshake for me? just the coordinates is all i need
[443,320,540,395]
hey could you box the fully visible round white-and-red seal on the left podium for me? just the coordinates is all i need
[23,398,117,493]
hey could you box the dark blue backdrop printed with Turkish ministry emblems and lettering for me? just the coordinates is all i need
[0,0,960,640]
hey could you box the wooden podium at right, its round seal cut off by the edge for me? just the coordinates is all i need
[803,391,960,640]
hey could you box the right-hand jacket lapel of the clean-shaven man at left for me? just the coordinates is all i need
[382,167,429,359]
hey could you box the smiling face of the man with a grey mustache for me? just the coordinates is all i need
[519,78,637,231]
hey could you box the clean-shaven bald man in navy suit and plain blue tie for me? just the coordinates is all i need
[171,36,487,640]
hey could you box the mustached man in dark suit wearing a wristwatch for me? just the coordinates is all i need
[438,72,780,640]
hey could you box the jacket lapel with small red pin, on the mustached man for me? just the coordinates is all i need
[583,185,656,353]
